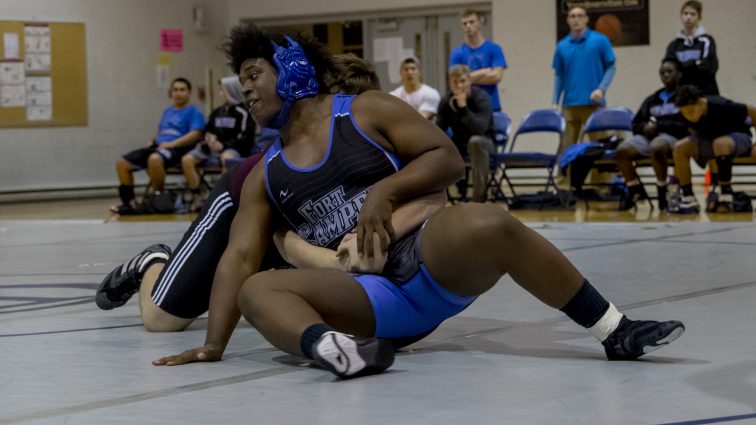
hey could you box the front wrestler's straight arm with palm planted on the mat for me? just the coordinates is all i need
[153,164,272,366]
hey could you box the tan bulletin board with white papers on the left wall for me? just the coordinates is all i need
[0,21,88,127]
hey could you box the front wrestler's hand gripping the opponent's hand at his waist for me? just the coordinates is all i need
[354,186,394,258]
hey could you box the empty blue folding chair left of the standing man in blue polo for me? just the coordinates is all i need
[494,109,565,200]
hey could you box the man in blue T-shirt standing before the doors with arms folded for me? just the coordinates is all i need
[449,10,507,111]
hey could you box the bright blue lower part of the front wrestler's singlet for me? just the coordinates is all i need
[354,262,477,338]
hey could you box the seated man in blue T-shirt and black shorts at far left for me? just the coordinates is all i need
[111,78,205,214]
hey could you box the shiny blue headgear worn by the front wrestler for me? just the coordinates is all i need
[268,37,319,129]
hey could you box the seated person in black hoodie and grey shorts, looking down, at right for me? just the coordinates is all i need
[617,58,688,211]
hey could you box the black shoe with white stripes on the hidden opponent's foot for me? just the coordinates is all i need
[95,244,171,310]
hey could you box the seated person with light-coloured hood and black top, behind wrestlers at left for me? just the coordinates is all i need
[181,76,255,211]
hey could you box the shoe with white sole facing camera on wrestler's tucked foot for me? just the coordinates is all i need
[312,332,394,378]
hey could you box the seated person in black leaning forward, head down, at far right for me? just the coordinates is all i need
[670,85,756,214]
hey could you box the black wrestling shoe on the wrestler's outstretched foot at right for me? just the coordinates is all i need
[601,316,685,360]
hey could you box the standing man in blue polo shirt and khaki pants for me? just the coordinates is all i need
[552,7,616,161]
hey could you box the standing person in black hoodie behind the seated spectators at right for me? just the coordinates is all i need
[666,0,719,95]
